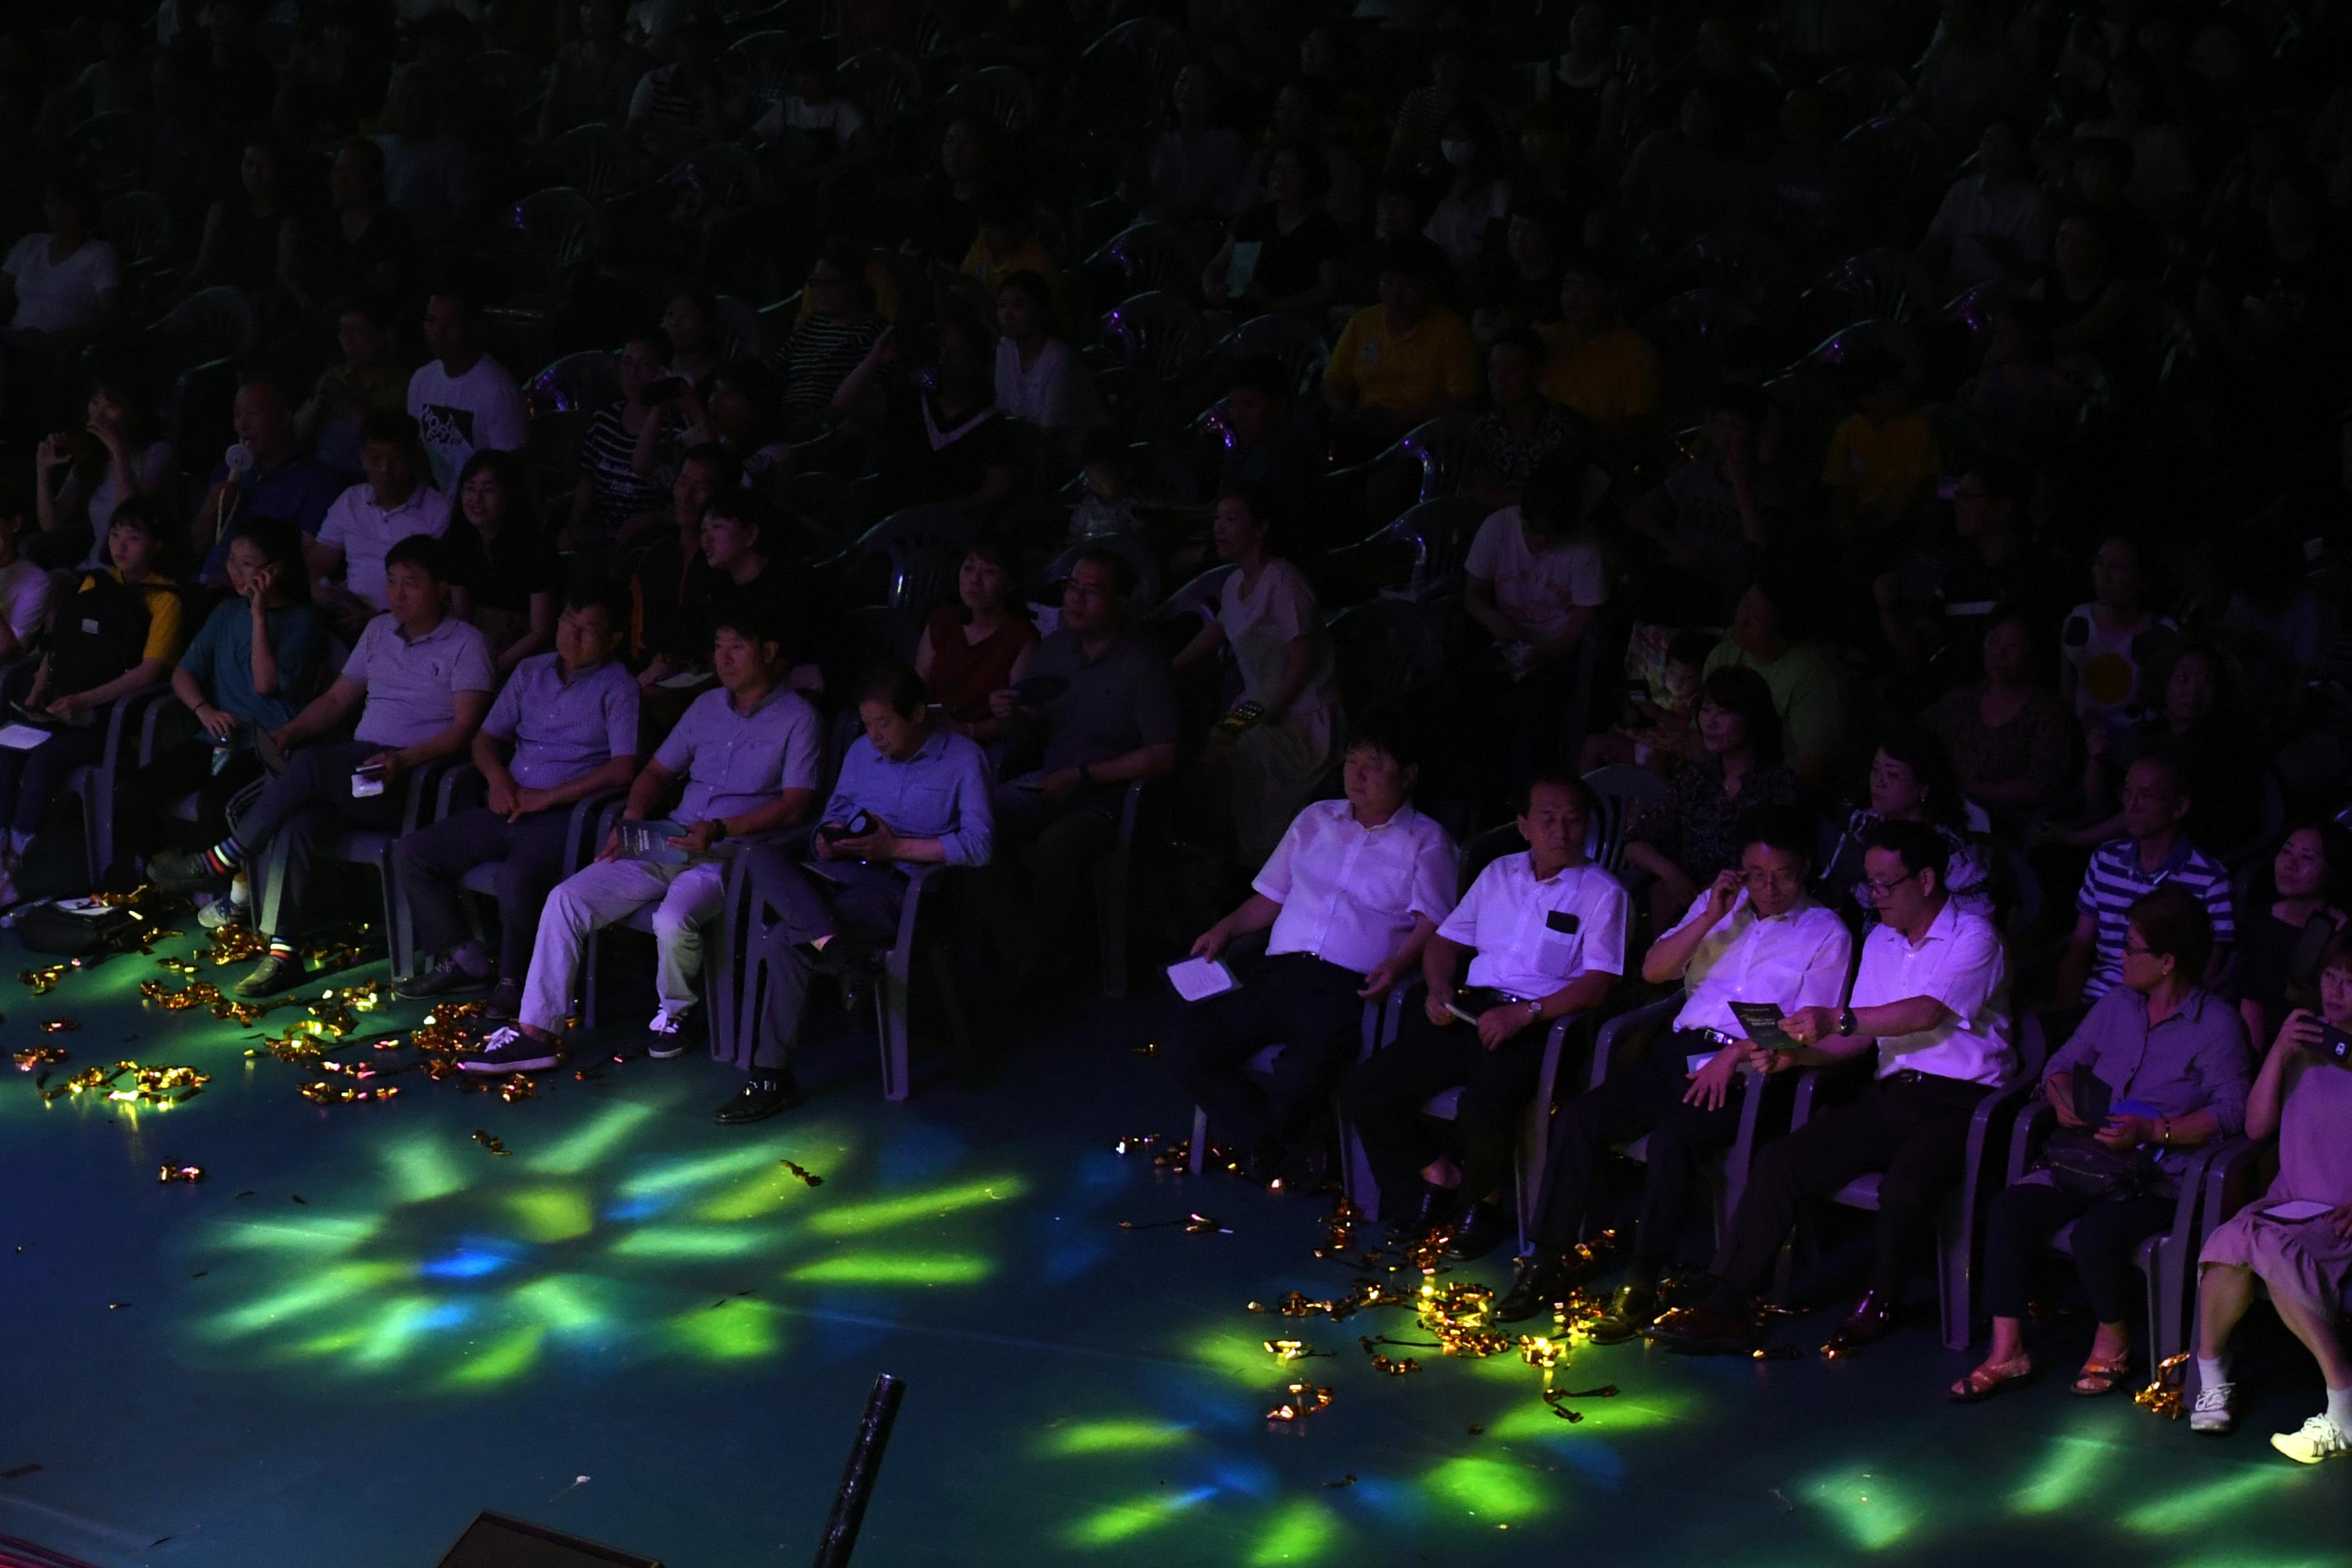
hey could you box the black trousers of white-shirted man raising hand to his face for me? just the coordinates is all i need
[1533,1030,1757,1267]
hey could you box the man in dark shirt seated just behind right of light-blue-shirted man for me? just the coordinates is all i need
[988,550,1176,990]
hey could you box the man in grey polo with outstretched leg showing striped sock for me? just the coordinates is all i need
[148,534,498,997]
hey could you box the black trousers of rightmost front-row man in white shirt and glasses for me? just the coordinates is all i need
[1710,1077,1988,1312]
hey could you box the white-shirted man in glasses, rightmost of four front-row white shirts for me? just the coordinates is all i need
[1649,823,2015,1354]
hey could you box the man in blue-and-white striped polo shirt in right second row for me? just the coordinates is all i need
[2053,757,2237,1006]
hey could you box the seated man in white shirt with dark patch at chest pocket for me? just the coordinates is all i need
[1343,774,1627,1258]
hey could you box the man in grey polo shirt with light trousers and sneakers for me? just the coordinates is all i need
[458,607,825,1072]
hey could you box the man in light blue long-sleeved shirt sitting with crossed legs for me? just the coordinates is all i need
[715,665,995,1126]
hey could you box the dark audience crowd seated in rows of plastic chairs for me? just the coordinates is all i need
[0,0,2352,1462]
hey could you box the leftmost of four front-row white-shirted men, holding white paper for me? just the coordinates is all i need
[1166,714,1453,1185]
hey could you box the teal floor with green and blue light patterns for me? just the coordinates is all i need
[0,936,2352,1568]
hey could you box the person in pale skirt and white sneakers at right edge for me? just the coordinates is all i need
[2190,931,2352,1465]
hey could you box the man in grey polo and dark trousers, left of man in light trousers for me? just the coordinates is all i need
[393,583,638,1018]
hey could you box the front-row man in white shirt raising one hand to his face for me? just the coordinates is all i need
[1496,807,1854,1345]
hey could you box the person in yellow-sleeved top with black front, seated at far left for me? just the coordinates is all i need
[0,496,188,905]
